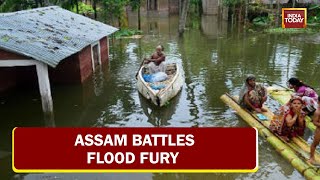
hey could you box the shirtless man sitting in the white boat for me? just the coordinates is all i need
[144,45,166,74]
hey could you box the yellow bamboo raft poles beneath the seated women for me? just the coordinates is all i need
[221,94,320,179]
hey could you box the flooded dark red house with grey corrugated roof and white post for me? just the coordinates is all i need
[0,6,118,112]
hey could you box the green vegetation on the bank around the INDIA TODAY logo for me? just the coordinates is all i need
[222,0,320,33]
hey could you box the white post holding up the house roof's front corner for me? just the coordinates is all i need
[36,62,53,119]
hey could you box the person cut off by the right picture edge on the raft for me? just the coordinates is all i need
[308,97,320,164]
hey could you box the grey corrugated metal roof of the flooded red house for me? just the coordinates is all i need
[0,6,118,67]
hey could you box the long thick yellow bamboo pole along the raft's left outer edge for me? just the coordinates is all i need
[220,94,320,179]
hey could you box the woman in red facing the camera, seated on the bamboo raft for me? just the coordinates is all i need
[270,96,306,141]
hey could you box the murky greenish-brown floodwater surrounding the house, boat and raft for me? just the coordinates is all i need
[0,16,320,180]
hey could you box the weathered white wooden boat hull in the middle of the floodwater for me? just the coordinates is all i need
[137,63,184,107]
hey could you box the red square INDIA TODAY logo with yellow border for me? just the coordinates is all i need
[282,8,307,28]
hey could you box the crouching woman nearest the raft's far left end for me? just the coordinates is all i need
[239,74,267,113]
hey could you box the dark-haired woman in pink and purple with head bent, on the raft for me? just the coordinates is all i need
[288,78,318,115]
